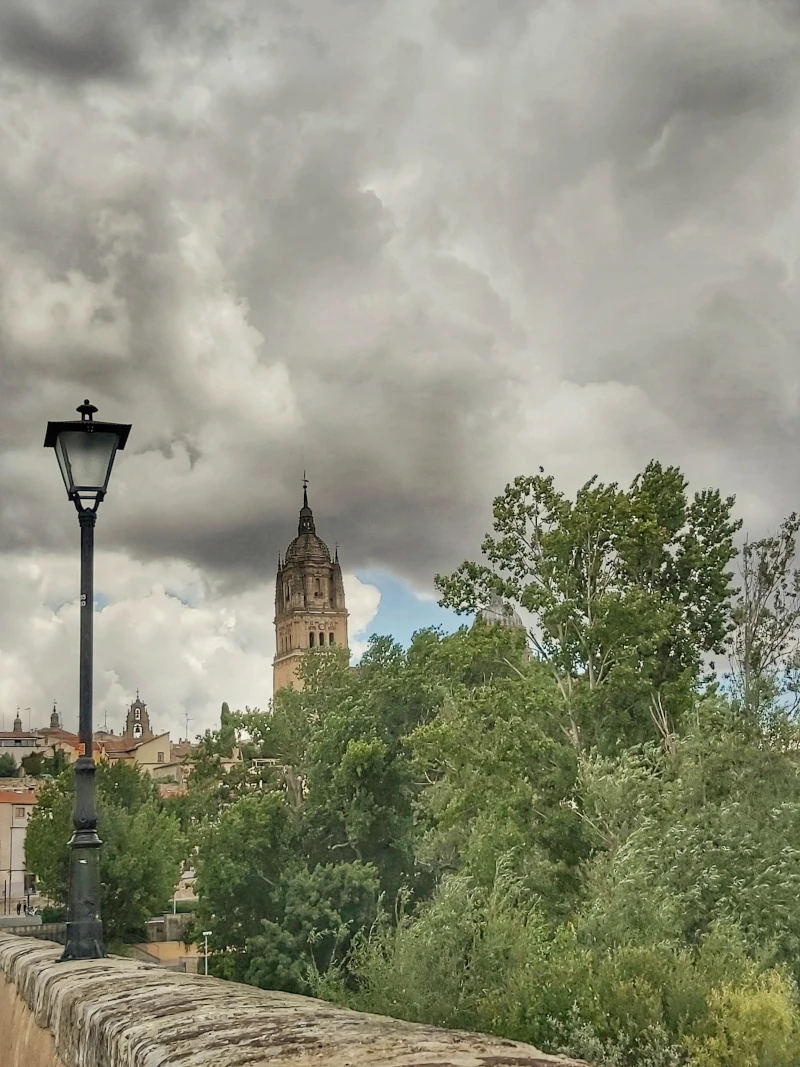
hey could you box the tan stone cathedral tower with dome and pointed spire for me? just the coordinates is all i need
[272,478,348,692]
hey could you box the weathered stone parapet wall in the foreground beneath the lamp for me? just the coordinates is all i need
[0,933,578,1067]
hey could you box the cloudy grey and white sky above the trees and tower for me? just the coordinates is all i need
[0,0,800,734]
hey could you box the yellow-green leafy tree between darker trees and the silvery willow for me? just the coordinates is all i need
[407,665,589,914]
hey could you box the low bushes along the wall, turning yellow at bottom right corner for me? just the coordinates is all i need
[332,866,800,1067]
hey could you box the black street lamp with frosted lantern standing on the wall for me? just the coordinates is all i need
[45,400,130,959]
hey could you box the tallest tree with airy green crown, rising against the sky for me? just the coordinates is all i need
[436,461,740,749]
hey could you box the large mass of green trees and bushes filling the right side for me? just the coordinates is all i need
[33,463,800,1067]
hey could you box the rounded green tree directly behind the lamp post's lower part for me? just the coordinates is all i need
[26,763,186,942]
